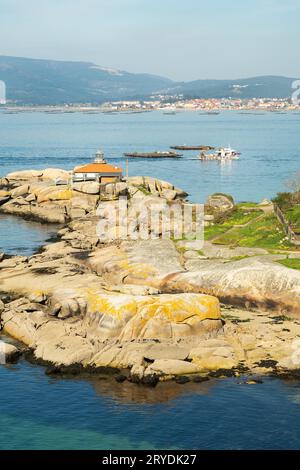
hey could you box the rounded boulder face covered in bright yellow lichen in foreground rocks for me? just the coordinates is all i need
[87,289,220,339]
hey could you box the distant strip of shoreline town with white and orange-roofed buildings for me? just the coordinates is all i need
[0,96,300,114]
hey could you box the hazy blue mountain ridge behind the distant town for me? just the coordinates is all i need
[0,56,294,105]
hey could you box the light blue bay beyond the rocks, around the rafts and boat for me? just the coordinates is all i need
[0,111,300,202]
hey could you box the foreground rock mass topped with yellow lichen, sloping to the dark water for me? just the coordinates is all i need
[1,289,222,375]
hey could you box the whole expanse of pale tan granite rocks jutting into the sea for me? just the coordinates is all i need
[0,169,300,385]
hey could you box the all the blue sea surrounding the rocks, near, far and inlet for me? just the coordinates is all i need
[0,108,300,449]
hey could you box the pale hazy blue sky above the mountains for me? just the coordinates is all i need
[0,0,300,80]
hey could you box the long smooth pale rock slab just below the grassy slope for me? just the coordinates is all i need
[88,239,300,316]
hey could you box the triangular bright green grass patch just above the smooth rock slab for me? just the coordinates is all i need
[214,215,291,250]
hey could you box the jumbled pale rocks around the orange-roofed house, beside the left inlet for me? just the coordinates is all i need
[0,168,187,224]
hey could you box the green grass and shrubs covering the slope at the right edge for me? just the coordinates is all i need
[205,184,300,252]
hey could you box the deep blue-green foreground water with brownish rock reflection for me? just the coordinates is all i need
[0,362,300,449]
